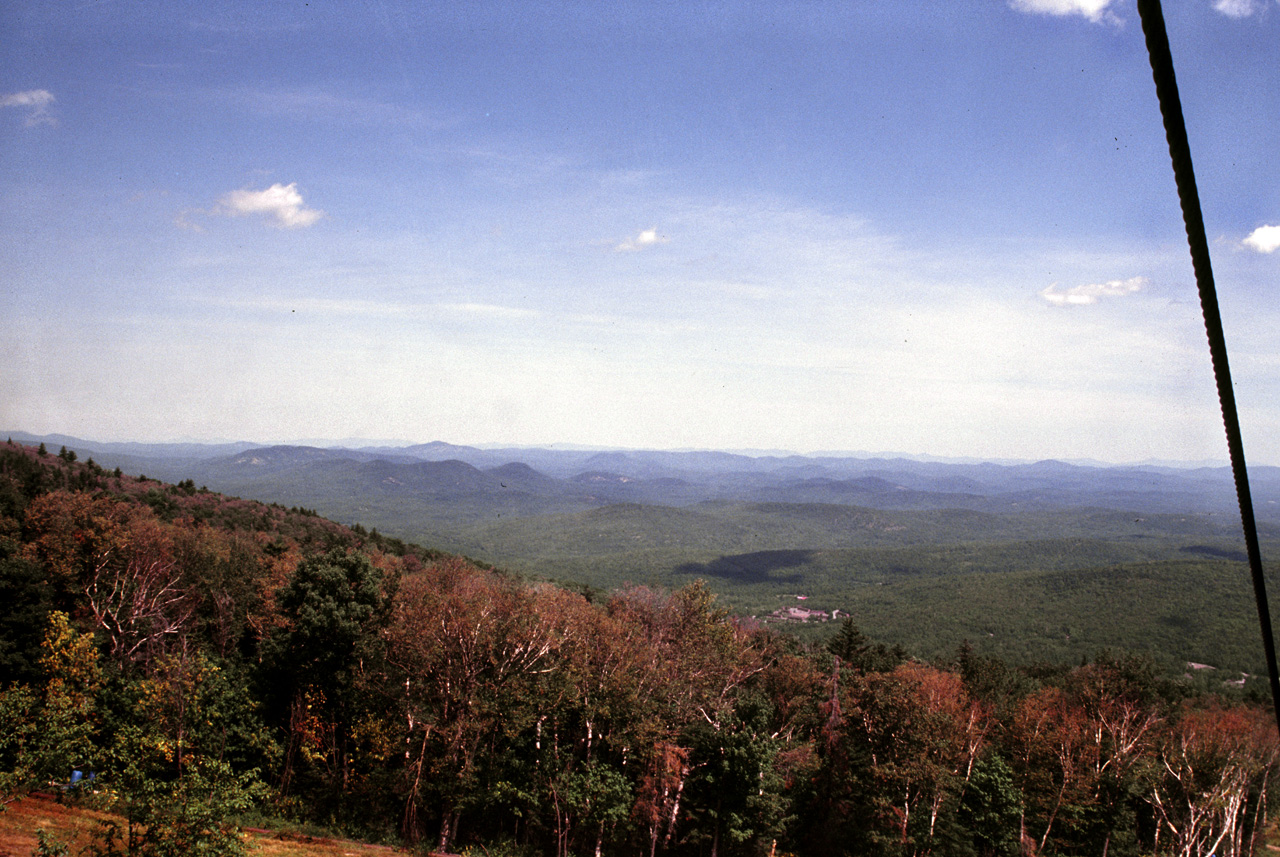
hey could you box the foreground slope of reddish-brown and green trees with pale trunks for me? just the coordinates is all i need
[0,443,1280,857]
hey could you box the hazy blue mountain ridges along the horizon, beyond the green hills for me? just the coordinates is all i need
[12,432,1280,521]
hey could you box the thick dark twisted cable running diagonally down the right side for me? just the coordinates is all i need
[1138,0,1280,727]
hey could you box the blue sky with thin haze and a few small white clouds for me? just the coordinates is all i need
[0,0,1280,464]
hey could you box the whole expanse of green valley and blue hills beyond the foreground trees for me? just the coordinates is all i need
[13,432,1280,672]
